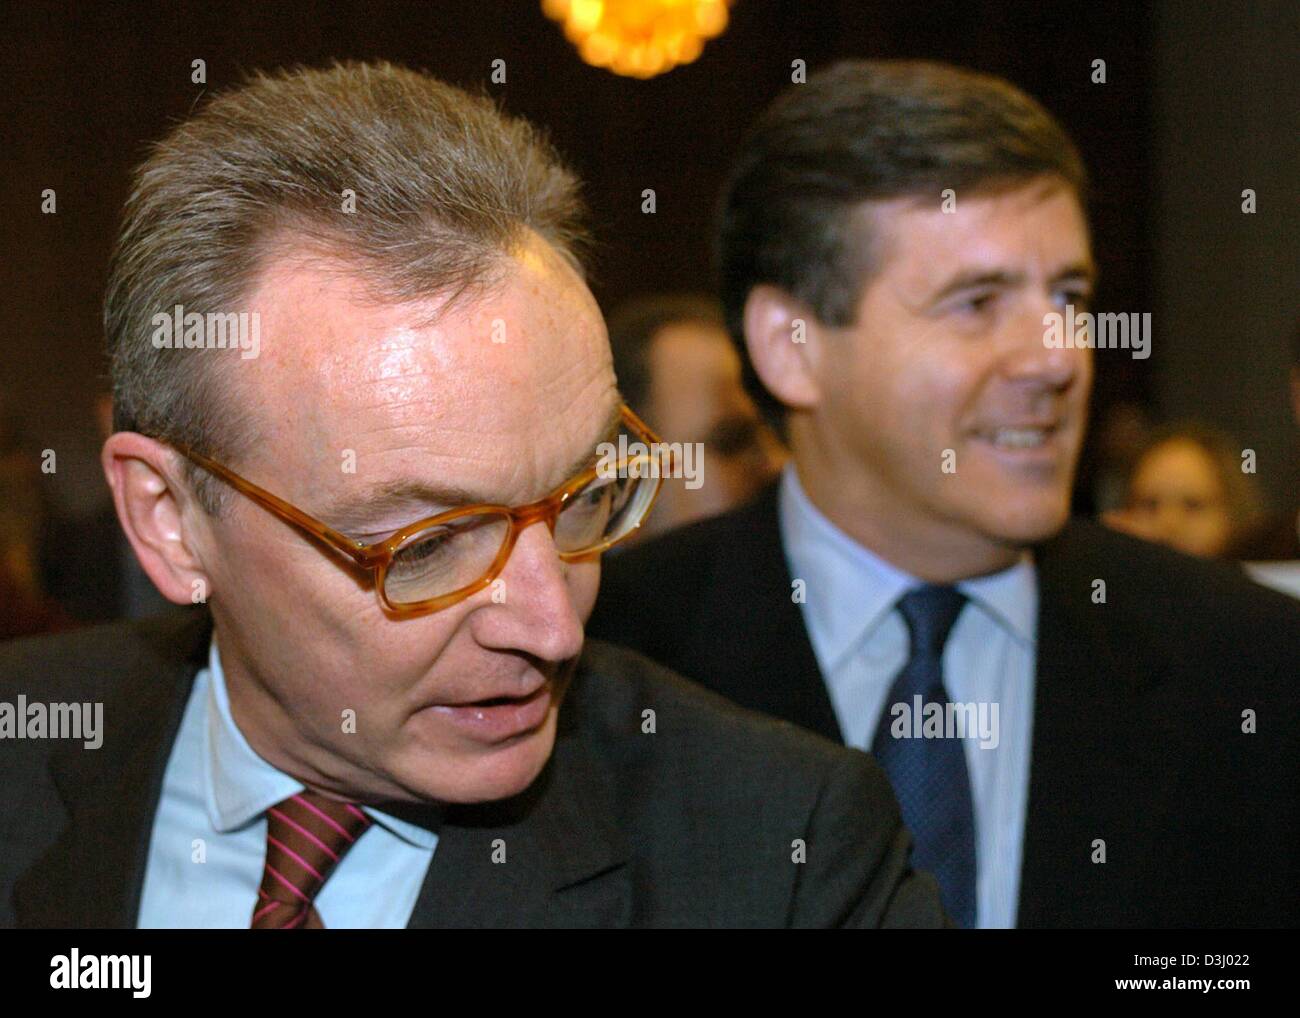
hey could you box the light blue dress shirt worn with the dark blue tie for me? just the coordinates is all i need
[779,464,1037,928]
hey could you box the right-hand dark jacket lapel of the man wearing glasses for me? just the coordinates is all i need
[410,676,632,928]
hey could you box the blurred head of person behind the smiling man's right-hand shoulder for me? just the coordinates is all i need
[1102,423,1264,559]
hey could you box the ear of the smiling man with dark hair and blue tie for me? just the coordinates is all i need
[745,283,823,410]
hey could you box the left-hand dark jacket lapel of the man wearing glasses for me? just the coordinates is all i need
[14,611,212,928]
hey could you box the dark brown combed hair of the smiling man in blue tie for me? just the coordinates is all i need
[716,60,1087,432]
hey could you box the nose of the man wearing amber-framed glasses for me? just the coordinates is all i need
[476,523,582,662]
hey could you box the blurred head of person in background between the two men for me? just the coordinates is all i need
[608,294,785,537]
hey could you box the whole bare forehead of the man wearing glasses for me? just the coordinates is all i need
[227,243,618,523]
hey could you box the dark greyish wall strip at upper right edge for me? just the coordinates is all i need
[1152,3,1300,504]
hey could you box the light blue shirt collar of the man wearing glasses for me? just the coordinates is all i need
[203,634,438,849]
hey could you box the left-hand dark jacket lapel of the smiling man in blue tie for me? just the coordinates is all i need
[688,482,844,742]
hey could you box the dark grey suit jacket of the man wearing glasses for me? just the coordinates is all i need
[0,611,943,927]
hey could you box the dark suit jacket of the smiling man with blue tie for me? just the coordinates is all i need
[588,485,1300,927]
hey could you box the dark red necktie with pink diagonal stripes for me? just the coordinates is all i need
[250,792,372,930]
